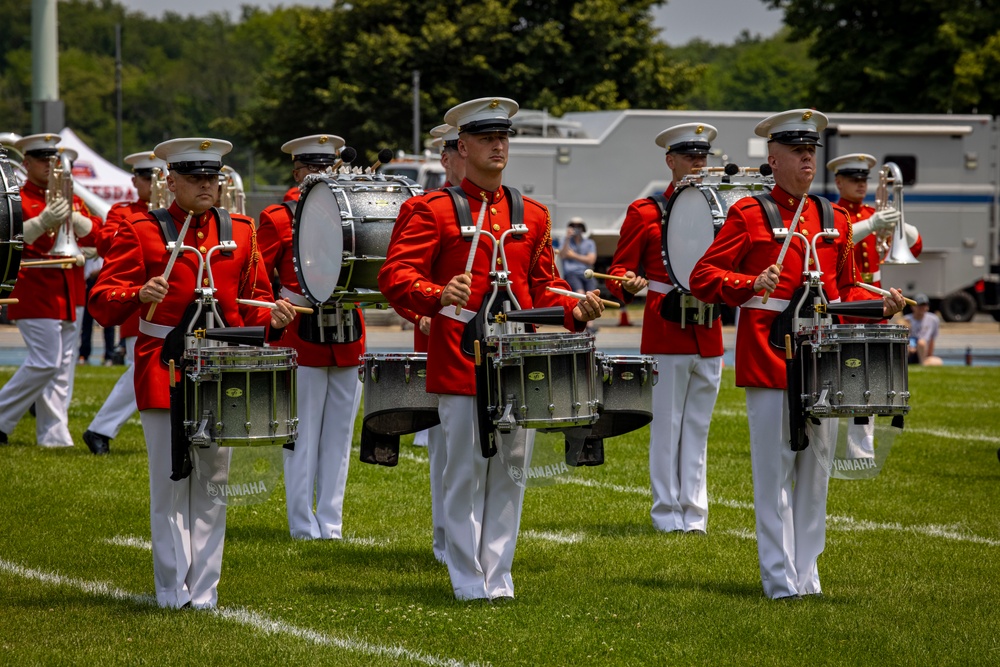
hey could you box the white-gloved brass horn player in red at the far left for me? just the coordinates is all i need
[0,134,101,447]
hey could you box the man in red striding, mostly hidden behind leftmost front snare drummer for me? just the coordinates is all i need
[83,151,167,454]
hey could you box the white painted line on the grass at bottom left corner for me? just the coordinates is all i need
[0,559,479,667]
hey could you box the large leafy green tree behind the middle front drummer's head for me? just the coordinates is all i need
[240,0,697,159]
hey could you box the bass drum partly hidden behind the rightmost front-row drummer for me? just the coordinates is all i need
[661,183,769,294]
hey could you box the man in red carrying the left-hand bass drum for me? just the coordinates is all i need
[257,134,365,540]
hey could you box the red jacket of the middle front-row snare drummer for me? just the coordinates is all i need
[378,179,584,396]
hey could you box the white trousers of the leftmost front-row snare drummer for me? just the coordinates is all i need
[139,410,229,609]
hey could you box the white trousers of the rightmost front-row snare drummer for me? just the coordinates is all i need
[746,387,837,598]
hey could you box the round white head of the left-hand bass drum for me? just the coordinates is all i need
[292,181,344,304]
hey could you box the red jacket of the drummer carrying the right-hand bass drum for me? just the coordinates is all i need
[607,184,723,357]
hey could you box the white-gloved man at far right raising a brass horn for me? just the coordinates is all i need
[826,153,923,287]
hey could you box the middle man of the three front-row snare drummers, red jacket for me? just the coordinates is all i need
[378,98,603,600]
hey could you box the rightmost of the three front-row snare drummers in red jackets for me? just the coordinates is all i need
[691,109,903,598]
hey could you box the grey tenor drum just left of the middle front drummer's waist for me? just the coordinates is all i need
[358,352,441,435]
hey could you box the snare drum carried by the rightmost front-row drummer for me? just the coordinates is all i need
[797,324,910,417]
